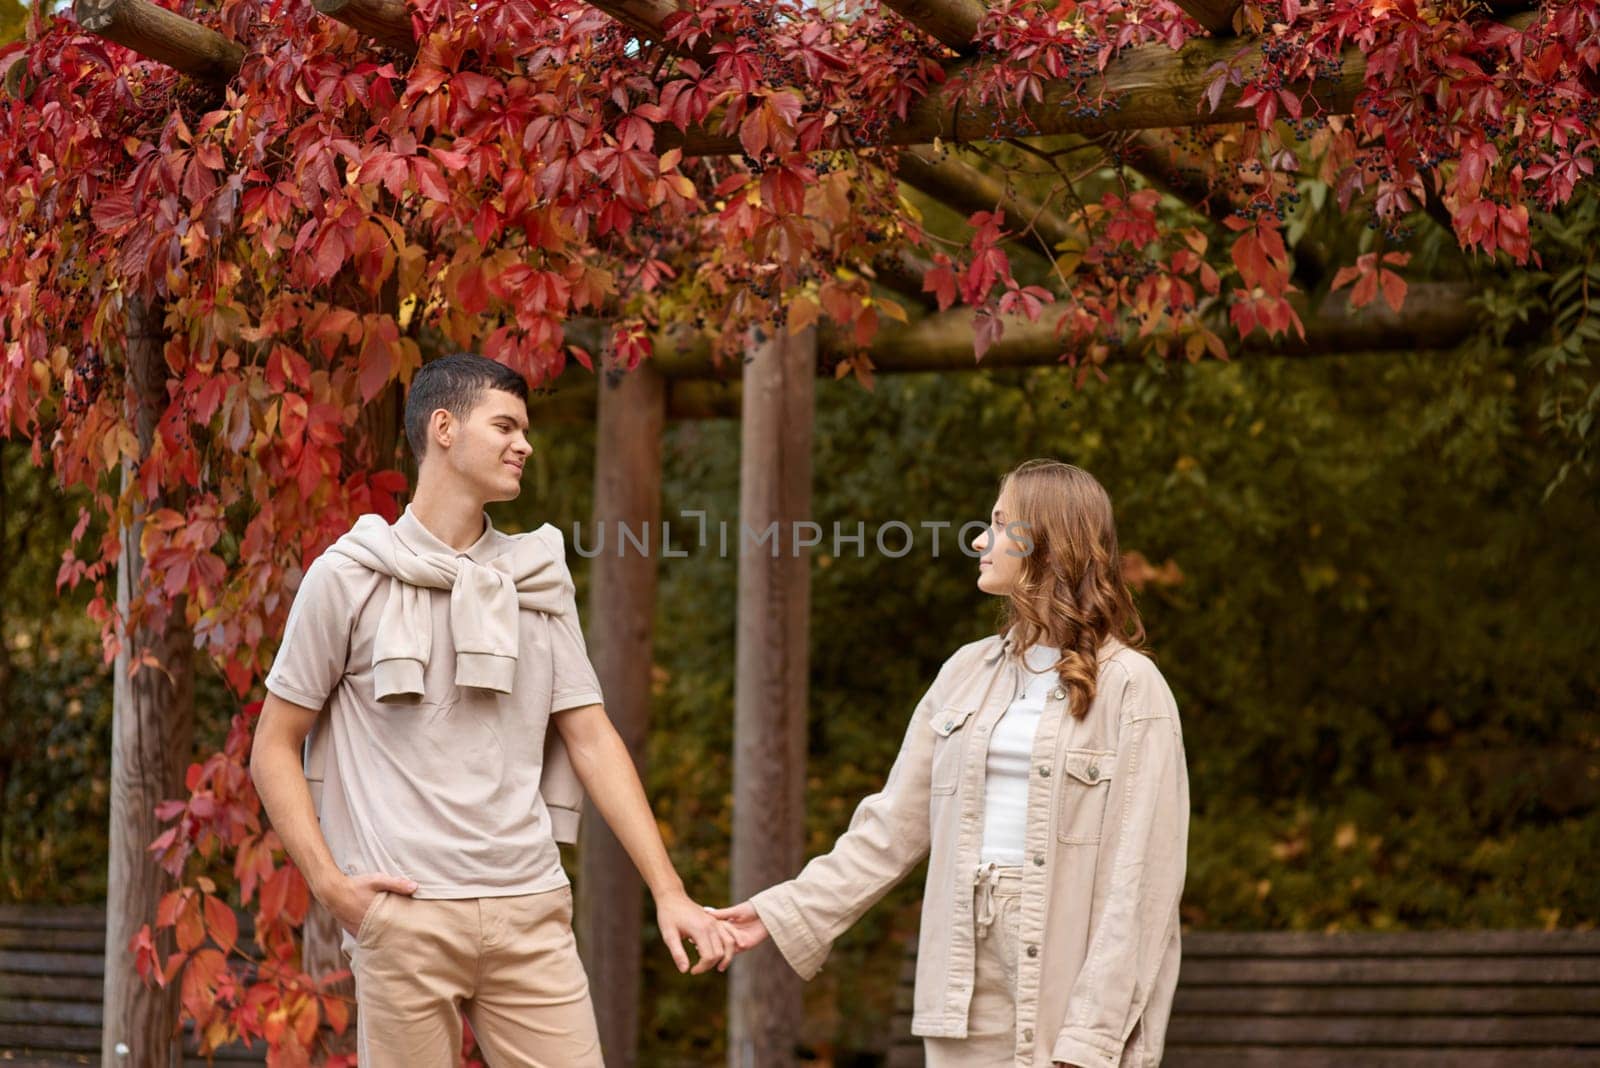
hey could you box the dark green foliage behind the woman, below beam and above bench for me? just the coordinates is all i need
[518,340,1600,1063]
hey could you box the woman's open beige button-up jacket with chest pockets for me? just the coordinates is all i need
[752,638,1189,1068]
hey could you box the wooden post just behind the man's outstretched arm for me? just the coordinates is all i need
[578,356,667,1068]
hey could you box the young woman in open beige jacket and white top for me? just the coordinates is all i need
[715,460,1189,1068]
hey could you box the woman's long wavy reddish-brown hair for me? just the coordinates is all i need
[1000,460,1146,719]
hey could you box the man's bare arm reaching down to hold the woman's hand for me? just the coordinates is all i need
[554,705,734,975]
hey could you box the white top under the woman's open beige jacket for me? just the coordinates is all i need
[981,646,1061,865]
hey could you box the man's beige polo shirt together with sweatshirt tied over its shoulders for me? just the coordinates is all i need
[267,508,602,899]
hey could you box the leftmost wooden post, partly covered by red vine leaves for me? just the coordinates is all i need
[101,297,194,1068]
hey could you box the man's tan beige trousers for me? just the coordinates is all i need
[350,887,602,1068]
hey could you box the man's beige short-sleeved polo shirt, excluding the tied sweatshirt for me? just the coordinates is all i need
[267,508,600,899]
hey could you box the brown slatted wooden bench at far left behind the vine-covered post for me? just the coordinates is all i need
[0,905,266,1068]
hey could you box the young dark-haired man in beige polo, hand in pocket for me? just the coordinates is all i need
[251,348,733,1068]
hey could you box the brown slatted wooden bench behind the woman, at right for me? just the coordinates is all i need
[890,931,1600,1068]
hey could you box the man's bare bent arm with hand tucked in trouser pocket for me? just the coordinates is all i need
[250,694,416,935]
